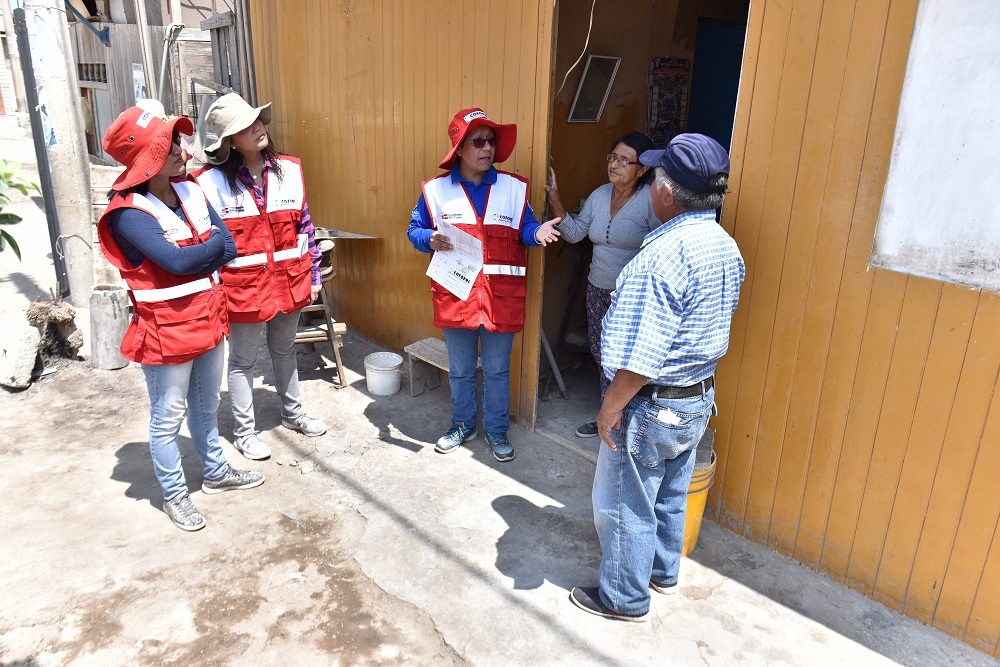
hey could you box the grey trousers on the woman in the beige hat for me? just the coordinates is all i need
[229,310,302,438]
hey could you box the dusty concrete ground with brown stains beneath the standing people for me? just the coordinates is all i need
[0,116,998,667]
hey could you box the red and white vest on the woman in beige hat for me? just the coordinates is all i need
[194,155,312,323]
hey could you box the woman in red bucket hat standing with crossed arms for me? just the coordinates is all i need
[98,107,264,530]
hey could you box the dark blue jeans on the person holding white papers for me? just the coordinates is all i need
[442,326,514,433]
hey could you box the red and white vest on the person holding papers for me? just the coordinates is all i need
[423,171,528,333]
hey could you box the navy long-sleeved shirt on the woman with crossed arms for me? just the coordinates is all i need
[108,197,236,276]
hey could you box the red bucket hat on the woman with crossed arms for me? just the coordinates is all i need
[102,107,194,190]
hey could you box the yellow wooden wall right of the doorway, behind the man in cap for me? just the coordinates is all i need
[708,0,1000,656]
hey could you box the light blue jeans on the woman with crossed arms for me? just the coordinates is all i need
[142,343,229,500]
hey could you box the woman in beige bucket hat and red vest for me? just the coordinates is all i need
[195,93,326,460]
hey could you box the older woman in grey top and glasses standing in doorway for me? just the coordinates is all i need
[545,132,661,438]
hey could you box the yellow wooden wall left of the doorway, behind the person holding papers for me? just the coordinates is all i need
[243,0,553,422]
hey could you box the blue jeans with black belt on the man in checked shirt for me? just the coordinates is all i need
[592,389,715,614]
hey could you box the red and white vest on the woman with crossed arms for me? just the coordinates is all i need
[97,181,229,365]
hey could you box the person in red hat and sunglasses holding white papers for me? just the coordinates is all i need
[406,109,559,462]
